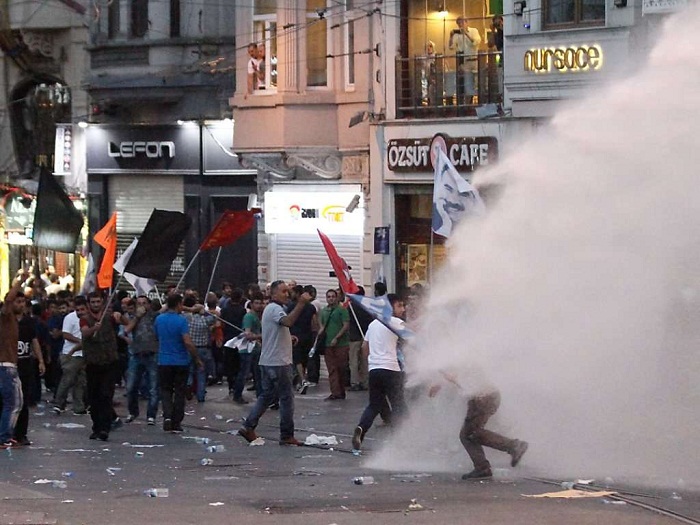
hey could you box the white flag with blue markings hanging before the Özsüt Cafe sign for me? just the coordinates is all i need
[432,149,485,237]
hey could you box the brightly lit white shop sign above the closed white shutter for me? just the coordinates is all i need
[264,191,364,235]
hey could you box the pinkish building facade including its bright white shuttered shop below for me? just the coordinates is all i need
[230,0,374,293]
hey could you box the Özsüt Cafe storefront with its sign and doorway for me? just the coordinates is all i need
[368,119,533,292]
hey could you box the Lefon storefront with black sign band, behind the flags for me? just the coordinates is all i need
[87,121,257,291]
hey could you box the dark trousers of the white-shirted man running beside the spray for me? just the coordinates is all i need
[358,368,407,433]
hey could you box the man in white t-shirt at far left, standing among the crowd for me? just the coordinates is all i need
[51,297,87,415]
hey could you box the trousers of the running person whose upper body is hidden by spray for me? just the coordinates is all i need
[459,392,517,470]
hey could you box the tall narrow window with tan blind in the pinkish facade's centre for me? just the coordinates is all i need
[306,0,328,87]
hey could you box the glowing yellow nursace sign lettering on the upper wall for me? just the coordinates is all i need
[523,44,603,73]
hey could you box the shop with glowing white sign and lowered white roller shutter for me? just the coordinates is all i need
[264,184,365,292]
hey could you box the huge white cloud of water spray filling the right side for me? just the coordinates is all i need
[370,7,700,485]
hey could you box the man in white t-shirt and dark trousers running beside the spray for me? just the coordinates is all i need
[352,293,406,450]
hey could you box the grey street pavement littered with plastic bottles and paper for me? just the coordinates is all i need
[0,383,700,525]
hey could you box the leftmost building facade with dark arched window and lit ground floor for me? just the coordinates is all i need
[0,0,88,294]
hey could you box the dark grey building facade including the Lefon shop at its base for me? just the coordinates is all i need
[86,0,257,291]
